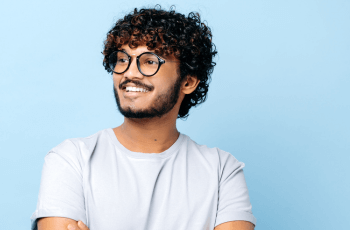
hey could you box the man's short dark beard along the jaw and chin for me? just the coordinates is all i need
[113,77,181,118]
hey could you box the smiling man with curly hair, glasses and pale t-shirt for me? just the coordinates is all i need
[32,5,256,230]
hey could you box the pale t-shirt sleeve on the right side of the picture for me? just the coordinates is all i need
[215,152,256,227]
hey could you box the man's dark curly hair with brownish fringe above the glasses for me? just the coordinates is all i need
[103,5,217,118]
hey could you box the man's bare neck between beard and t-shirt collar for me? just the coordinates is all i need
[113,113,179,153]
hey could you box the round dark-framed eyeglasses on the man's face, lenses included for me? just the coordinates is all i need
[109,50,178,77]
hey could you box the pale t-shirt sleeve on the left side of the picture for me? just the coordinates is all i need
[31,140,86,230]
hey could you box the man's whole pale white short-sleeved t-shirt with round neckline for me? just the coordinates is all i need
[31,128,256,230]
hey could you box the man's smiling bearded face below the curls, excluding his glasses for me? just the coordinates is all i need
[113,45,181,118]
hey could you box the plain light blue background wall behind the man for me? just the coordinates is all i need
[0,0,350,230]
